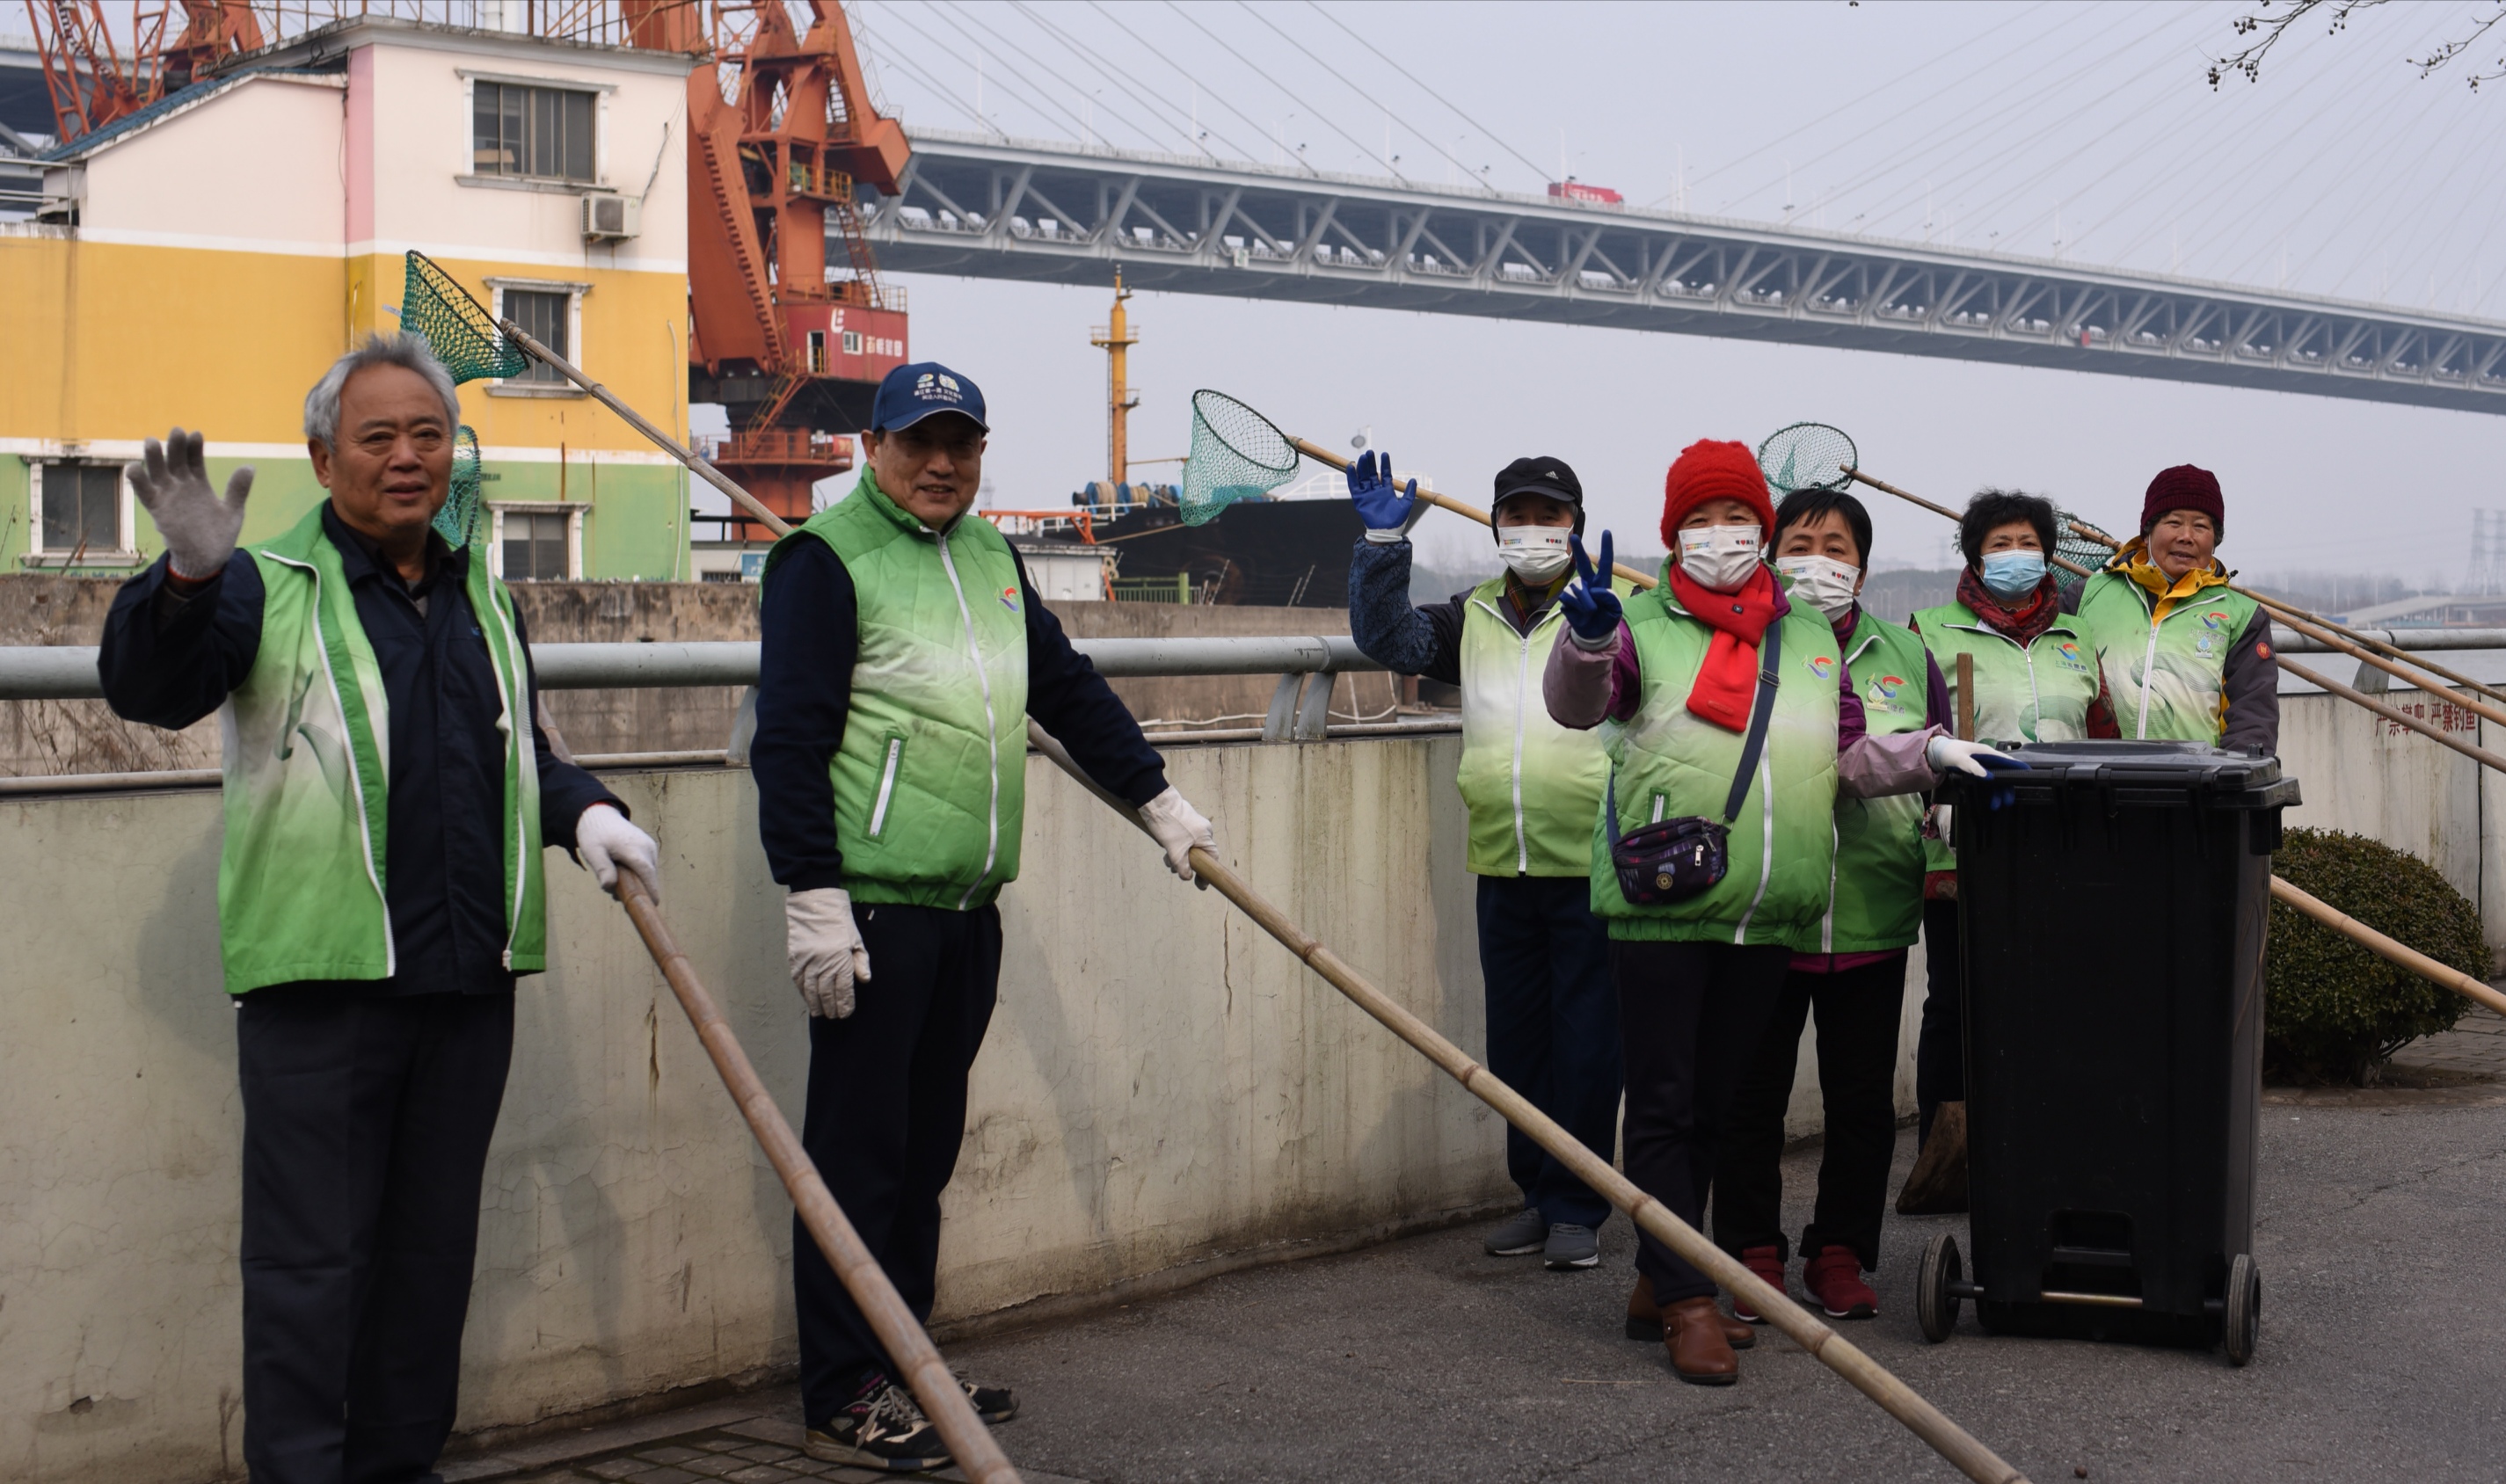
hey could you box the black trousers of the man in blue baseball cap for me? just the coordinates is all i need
[792,902,1000,1426]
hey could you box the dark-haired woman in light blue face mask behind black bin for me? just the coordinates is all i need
[1899,489,2115,1211]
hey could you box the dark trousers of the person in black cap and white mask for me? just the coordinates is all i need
[1479,875,1619,1228]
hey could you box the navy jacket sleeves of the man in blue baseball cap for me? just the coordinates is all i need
[749,531,1165,892]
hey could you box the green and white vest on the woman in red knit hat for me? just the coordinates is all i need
[1592,573,1839,953]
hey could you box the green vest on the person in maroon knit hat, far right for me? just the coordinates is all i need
[2080,571,2255,747]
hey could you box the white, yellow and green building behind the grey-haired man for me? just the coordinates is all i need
[0,18,692,582]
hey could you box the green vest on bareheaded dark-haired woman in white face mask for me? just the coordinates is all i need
[1812,612,1930,953]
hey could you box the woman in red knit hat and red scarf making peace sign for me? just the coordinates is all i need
[1541,441,2010,1386]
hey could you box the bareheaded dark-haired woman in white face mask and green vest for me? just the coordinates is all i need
[1714,489,1949,1319]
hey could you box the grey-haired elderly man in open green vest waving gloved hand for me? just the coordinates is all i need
[100,336,659,1484]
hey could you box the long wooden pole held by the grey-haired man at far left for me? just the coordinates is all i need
[619,869,1017,1484]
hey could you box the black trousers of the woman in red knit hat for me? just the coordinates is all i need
[1609,942,1792,1304]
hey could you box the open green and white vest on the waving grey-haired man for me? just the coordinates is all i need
[218,506,549,995]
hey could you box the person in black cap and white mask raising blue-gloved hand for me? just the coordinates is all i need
[1348,454,1619,1271]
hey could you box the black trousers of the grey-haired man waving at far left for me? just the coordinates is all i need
[236,986,514,1484]
